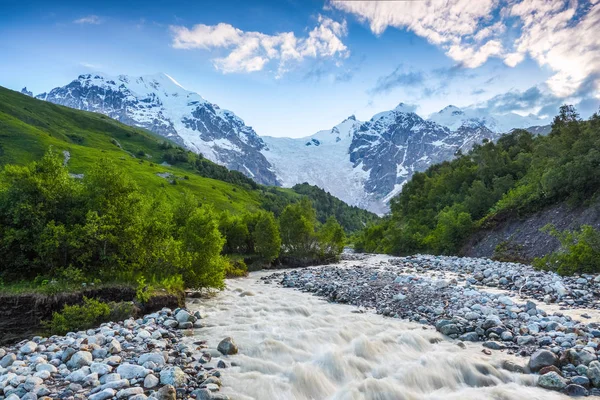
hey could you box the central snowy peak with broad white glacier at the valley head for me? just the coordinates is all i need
[262,103,468,214]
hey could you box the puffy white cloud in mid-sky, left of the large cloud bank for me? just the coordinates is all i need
[171,16,349,76]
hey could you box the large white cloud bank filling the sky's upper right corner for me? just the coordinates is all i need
[329,0,600,97]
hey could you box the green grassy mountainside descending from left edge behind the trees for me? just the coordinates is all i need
[0,87,376,233]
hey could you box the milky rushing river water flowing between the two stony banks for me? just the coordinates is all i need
[187,272,569,400]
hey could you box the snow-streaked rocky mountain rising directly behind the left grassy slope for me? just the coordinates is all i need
[36,74,279,185]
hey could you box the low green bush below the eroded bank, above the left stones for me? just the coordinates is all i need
[46,297,111,335]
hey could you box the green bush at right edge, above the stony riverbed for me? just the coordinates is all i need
[533,225,600,275]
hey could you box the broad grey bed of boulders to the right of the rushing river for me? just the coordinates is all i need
[263,255,600,396]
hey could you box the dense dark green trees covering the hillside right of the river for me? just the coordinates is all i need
[355,106,600,274]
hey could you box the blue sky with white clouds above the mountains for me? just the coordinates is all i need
[0,0,600,137]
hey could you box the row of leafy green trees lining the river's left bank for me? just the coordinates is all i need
[0,151,344,288]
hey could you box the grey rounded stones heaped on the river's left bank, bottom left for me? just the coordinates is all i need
[0,308,237,400]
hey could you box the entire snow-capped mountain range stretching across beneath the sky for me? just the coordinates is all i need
[27,73,547,214]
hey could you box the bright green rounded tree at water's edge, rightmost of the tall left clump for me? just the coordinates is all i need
[182,205,227,289]
